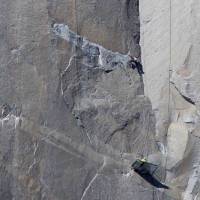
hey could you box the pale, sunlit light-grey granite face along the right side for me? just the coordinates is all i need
[140,0,200,200]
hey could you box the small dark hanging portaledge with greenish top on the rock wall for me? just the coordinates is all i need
[131,158,170,189]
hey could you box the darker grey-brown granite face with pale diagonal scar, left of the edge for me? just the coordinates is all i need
[0,0,161,200]
